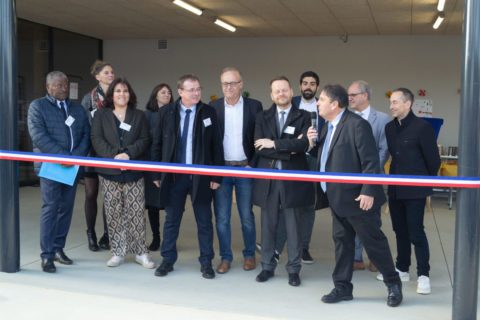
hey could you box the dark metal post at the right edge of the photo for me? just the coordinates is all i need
[452,0,480,320]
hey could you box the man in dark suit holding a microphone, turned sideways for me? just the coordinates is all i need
[308,85,403,307]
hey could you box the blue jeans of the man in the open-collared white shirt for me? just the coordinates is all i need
[214,177,256,262]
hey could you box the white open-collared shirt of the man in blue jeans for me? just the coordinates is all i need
[223,97,247,161]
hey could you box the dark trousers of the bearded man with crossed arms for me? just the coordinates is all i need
[261,180,302,273]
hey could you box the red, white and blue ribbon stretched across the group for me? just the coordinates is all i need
[0,150,480,188]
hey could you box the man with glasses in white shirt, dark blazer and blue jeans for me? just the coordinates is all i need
[210,67,263,273]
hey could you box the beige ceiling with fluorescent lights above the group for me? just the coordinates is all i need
[16,0,464,40]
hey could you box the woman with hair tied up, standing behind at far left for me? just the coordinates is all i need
[82,60,115,251]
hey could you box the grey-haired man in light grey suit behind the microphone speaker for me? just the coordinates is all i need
[348,80,390,272]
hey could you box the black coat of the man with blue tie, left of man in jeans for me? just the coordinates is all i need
[152,99,224,206]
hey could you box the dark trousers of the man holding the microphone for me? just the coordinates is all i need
[332,208,400,291]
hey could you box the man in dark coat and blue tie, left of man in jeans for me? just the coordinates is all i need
[152,74,224,279]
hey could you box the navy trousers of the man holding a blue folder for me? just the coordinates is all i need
[40,178,77,259]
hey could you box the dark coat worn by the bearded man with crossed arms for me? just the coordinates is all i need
[253,104,315,208]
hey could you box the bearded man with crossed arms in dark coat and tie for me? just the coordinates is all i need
[253,77,314,286]
